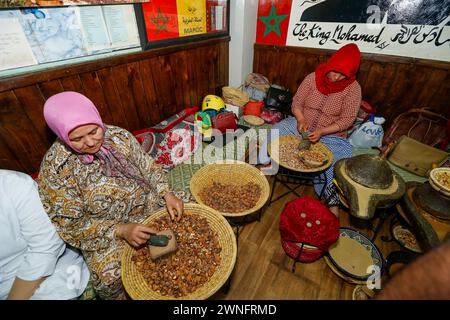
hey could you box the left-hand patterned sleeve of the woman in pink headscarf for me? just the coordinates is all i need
[39,159,116,251]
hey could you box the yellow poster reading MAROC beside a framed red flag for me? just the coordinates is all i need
[177,0,206,37]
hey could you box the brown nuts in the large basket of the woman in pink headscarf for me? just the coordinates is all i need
[132,212,222,298]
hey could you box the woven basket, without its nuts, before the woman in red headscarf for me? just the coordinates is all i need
[268,134,333,172]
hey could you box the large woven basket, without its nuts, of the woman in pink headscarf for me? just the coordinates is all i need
[122,203,237,300]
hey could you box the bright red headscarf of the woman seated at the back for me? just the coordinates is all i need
[315,43,361,94]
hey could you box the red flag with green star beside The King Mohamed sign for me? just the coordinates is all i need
[256,0,292,46]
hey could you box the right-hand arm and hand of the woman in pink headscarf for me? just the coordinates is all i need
[126,127,184,220]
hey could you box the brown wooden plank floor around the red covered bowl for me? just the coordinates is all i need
[211,178,400,300]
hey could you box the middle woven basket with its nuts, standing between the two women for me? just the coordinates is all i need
[190,160,270,217]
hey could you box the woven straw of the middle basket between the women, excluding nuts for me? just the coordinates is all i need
[190,160,270,217]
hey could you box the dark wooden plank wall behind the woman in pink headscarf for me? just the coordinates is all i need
[0,37,229,173]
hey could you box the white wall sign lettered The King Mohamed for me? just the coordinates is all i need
[286,0,450,62]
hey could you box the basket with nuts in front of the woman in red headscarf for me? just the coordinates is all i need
[268,135,333,172]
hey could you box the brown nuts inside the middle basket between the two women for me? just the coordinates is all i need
[200,182,261,213]
